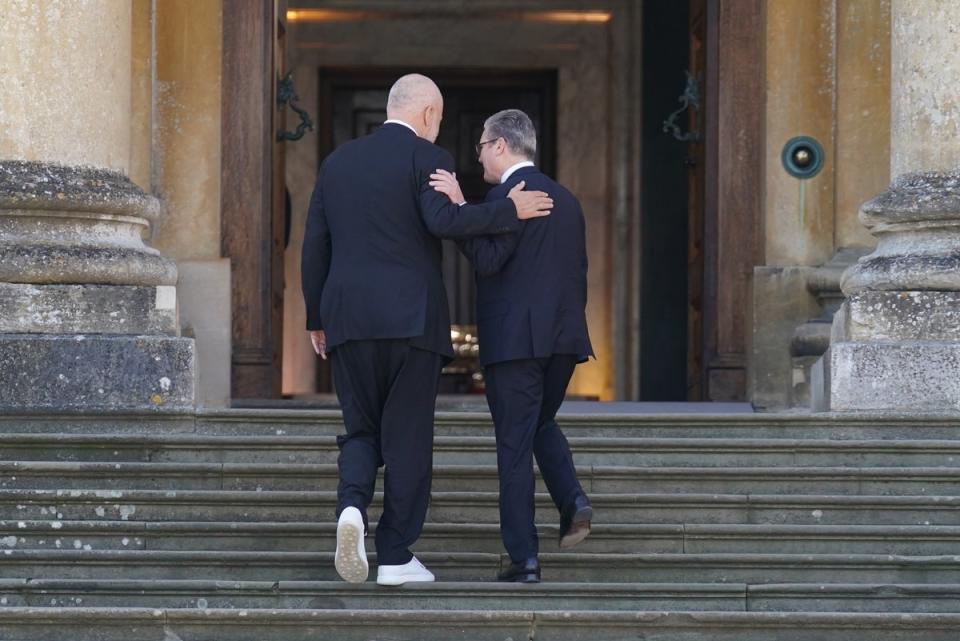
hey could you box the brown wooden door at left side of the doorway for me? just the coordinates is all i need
[220,0,286,398]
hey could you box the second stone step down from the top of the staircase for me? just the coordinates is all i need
[0,433,960,467]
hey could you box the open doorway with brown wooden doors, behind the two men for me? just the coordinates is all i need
[227,0,764,401]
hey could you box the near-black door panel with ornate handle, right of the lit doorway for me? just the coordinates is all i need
[639,0,713,401]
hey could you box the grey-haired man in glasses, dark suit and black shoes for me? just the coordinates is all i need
[430,109,593,583]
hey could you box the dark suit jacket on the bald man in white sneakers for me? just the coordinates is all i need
[301,123,520,358]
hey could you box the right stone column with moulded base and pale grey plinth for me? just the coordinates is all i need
[824,0,960,411]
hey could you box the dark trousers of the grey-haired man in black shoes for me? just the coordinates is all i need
[484,354,583,562]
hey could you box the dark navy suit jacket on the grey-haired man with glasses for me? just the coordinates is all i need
[458,167,593,365]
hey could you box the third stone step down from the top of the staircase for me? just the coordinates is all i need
[0,461,960,496]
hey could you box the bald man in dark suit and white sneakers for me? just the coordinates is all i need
[302,74,553,585]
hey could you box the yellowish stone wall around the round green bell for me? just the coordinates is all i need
[750,0,890,409]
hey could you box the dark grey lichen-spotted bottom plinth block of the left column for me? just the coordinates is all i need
[0,334,196,411]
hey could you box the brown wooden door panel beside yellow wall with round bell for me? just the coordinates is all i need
[702,0,760,401]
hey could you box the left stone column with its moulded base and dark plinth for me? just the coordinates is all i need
[0,0,194,411]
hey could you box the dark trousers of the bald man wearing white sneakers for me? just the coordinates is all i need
[330,339,443,565]
